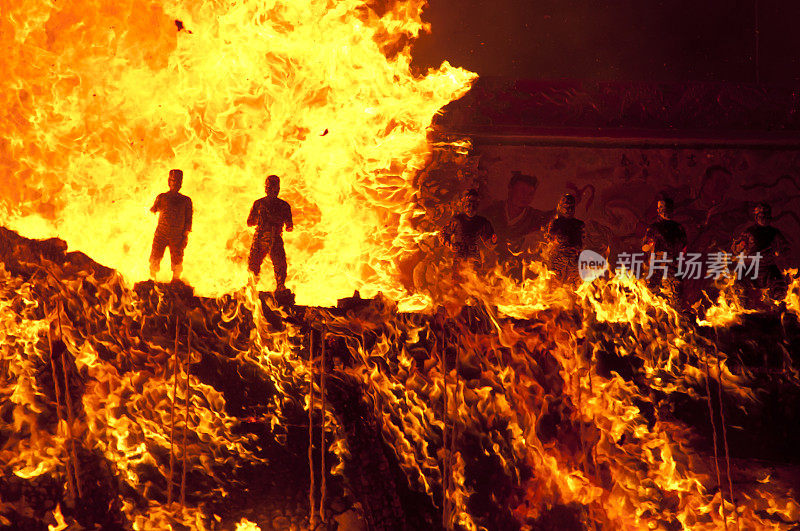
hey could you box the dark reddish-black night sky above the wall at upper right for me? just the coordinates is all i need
[413,0,800,84]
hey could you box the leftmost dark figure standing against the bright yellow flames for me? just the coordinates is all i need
[150,170,192,281]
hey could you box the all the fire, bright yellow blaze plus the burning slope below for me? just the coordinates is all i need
[0,0,800,531]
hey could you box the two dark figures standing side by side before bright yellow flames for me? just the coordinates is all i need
[150,170,294,292]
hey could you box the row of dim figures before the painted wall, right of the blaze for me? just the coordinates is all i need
[439,172,789,305]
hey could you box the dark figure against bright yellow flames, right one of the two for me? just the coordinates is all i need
[247,175,294,291]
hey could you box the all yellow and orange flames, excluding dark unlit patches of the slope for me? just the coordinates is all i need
[0,0,800,529]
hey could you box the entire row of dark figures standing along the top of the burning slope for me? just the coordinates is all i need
[150,169,788,303]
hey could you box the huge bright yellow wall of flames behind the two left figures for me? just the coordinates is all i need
[0,0,474,304]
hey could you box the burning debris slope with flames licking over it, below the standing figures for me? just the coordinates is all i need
[0,230,800,529]
